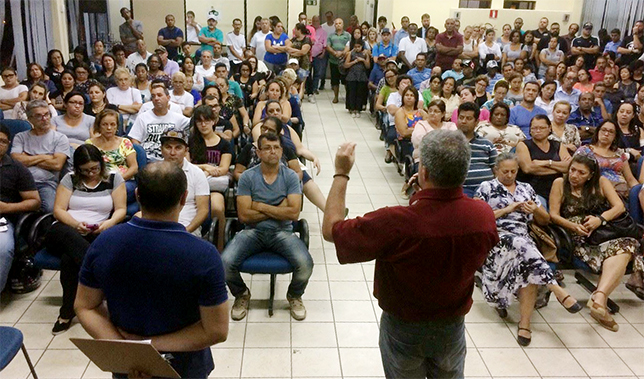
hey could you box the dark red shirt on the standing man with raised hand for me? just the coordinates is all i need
[333,187,499,322]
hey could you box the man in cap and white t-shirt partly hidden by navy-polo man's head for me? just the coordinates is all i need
[160,128,210,237]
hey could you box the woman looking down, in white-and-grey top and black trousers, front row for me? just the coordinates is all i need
[45,145,126,335]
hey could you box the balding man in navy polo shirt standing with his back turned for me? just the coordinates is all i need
[74,162,228,379]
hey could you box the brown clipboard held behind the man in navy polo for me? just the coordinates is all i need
[69,338,181,379]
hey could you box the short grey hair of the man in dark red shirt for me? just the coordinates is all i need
[420,130,471,188]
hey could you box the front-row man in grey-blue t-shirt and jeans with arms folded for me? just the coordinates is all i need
[221,133,313,320]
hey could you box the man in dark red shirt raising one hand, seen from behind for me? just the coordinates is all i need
[322,130,499,378]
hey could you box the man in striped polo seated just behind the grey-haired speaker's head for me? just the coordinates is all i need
[456,102,497,197]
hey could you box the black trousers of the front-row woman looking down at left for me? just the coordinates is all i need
[45,222,97,320]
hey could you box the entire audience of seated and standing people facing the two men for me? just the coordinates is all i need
[0,8,644,354]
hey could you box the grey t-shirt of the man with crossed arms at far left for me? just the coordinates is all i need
[11,129,70,183]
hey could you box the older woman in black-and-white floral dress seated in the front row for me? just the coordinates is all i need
[475,153,582,346]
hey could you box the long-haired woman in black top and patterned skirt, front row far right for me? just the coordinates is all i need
[550,151,644,332]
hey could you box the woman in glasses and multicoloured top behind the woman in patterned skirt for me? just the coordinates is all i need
[577,121,638,200]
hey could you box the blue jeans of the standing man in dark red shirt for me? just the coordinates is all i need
[379,312,467,378]
